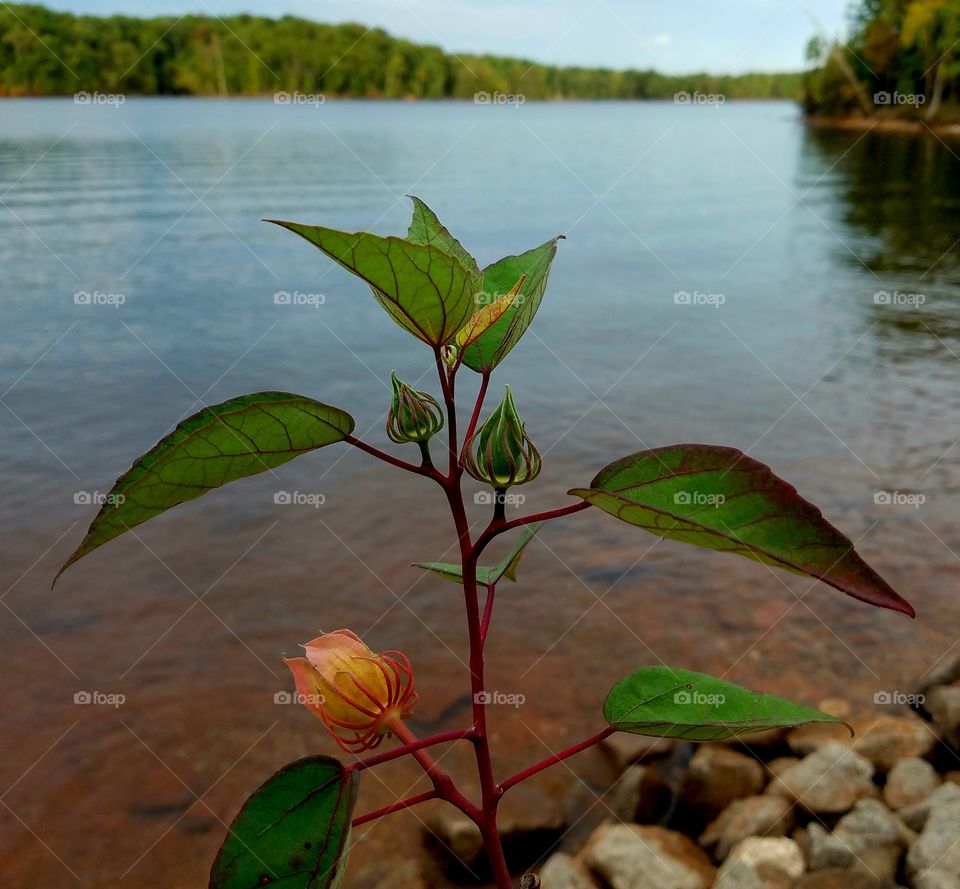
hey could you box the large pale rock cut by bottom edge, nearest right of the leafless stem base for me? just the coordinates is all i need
[580,823,716,889]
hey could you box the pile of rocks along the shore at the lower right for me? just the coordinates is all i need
[414,661,960,889]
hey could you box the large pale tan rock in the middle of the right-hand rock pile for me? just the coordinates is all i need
[776,743,877,814]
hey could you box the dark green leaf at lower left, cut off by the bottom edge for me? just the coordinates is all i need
[210,756,359,889]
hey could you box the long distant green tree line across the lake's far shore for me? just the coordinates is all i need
[0,4,801,99]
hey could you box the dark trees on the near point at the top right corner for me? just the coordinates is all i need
[804,0,960,122]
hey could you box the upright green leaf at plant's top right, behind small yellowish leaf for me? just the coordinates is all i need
[463,235,564,373]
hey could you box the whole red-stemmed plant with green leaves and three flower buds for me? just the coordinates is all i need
[58,198,913,889]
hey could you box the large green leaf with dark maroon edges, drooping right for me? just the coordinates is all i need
[569,444,914,617]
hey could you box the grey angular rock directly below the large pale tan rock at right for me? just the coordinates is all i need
[807,799,915,880]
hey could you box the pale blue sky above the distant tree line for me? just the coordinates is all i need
[41,0,846,73]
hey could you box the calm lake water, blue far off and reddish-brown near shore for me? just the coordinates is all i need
[0,99,960,889]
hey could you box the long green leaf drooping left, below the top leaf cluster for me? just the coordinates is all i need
[54,392,354,583]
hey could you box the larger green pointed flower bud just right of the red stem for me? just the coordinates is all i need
[463,386,540,490]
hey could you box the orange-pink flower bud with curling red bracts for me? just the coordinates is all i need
[284,630,417,753]
